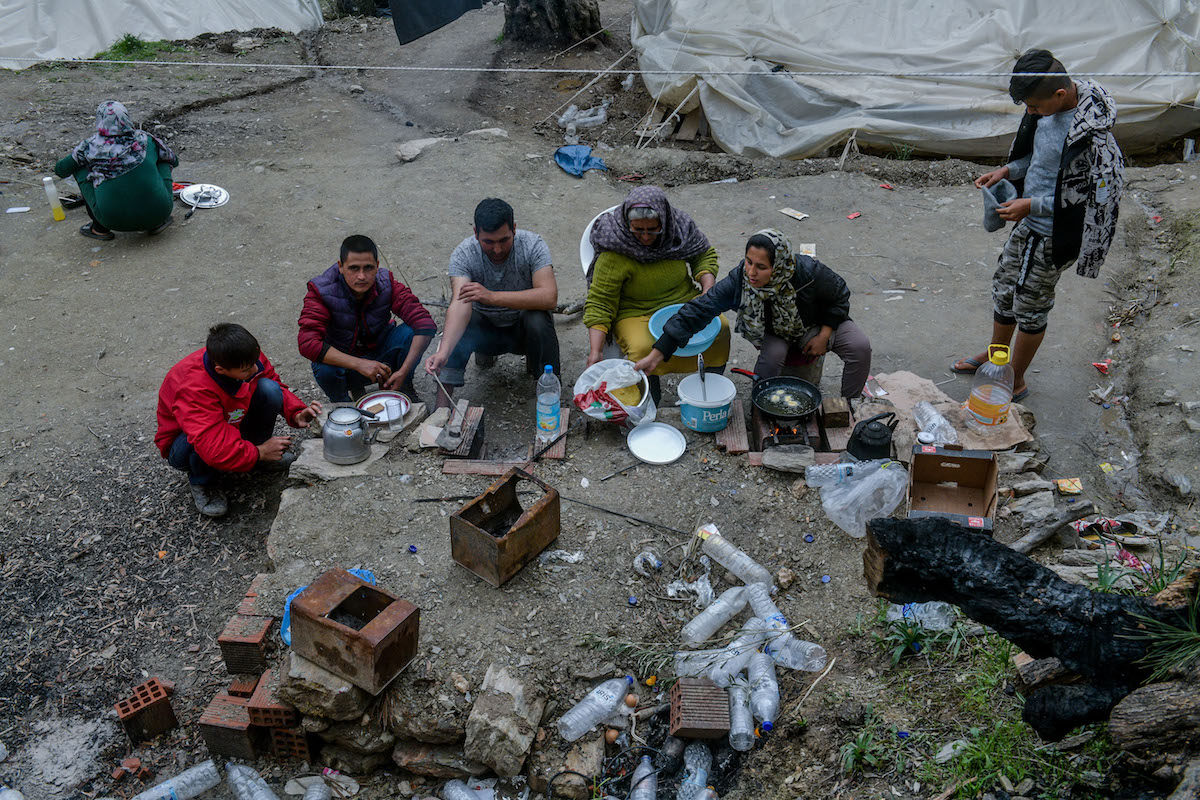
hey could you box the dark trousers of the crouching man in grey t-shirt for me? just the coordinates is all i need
[439,311,560,386]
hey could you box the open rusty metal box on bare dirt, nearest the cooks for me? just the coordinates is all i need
[450,469,562,587]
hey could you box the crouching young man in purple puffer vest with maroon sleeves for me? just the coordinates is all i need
[299,235,438,403]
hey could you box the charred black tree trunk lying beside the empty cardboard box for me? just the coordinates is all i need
[863,518,1200,739]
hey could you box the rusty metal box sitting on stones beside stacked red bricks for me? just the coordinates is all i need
[292,570,421,694]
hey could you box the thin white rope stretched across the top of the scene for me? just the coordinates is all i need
[7,56,1200,78]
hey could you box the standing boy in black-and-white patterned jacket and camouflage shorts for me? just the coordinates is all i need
[950,50,1124,402]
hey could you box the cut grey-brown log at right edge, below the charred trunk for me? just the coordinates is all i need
[1109,680,1200,758]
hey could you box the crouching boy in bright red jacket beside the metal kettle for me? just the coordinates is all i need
[154,323,320,517]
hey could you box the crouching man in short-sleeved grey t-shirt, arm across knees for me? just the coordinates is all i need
[425,198,560,407]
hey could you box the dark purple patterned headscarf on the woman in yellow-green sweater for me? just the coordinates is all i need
[590,186,709,264]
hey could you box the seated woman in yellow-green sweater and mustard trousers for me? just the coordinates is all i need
[583,186,730,391]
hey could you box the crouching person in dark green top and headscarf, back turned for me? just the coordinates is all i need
[54,100,179,241]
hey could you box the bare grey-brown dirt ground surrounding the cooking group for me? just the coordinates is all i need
[0,6,1200,800]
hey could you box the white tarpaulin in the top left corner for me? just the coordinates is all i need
[0,0,324,70]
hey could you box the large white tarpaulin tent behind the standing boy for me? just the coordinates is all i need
[631,0,1200,158]
